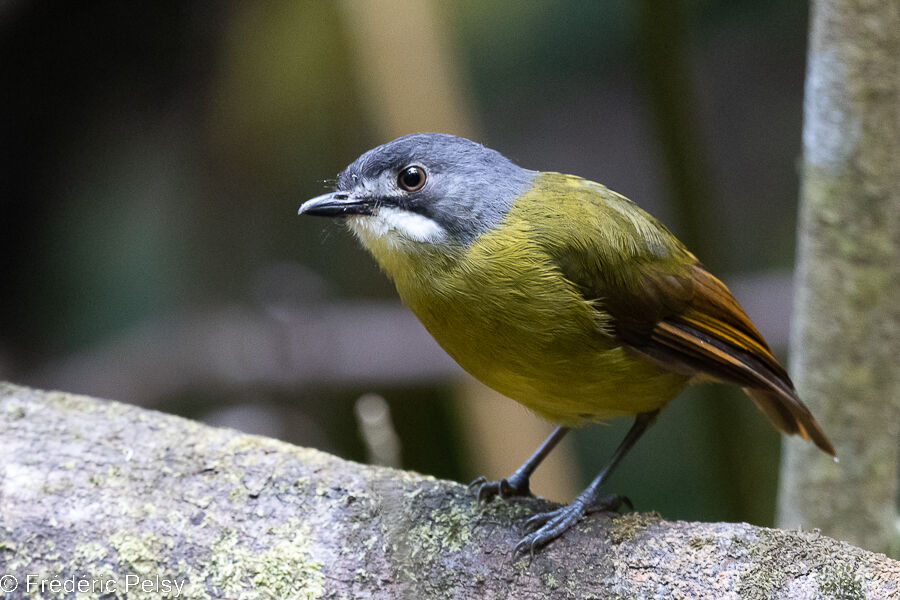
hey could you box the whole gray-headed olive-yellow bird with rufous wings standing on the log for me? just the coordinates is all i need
[299,133,835,554]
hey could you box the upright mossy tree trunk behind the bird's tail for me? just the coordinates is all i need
[779,0,900,556]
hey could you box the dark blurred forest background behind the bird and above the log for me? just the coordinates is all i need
[0,0,807,525]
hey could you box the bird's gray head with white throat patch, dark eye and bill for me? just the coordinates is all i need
[300,133,536,245]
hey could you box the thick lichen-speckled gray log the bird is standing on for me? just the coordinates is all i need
[0,384,900,599]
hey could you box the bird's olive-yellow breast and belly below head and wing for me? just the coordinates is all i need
[386,241,689,425]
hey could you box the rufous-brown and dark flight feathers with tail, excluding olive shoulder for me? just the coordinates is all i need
[568,254,835,456]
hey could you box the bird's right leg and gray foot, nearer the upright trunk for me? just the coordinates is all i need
[516,410,659,553]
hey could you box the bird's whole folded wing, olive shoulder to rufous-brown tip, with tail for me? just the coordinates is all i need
[554,178,834,455]
